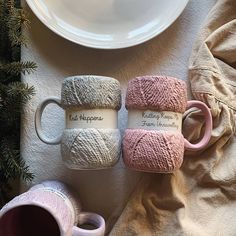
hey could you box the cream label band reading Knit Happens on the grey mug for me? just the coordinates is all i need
[66,109,118,129]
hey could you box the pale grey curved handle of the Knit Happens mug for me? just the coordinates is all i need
[35,97,62,144]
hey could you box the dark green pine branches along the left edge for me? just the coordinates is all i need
[0,0,36,207]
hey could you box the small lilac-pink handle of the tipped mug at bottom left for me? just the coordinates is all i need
[72,212,105,236]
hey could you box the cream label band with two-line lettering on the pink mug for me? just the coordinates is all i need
[127,110,182,132]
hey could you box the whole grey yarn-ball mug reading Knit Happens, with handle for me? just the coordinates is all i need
[35,75,121,169]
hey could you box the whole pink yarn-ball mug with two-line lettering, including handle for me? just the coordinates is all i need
[122,76,212,173]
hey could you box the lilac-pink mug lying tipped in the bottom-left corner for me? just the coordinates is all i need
[0,181,105,236]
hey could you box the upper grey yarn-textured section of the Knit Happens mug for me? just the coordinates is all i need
[61,75,121,110]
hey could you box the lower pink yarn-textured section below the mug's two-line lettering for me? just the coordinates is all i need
[123,129,184,172]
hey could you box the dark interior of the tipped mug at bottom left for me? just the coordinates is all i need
[0,205,60,236]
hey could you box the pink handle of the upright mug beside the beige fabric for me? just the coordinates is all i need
[184,101,212,151]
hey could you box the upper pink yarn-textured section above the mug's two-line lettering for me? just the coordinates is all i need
[125,76,187,113]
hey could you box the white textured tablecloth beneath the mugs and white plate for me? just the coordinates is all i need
[21,0,215,235]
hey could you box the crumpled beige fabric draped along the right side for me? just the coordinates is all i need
[110,0,236,236]
